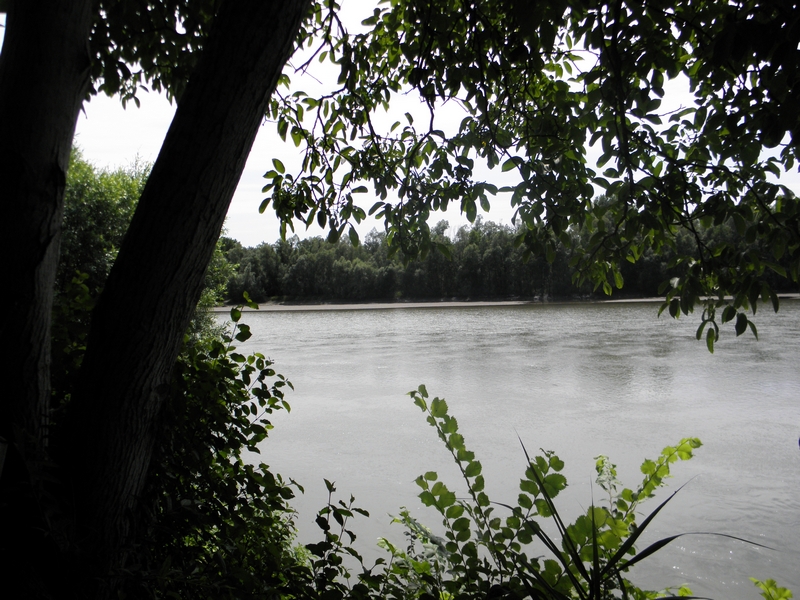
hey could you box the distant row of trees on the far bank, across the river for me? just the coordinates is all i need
[219,216,796,303]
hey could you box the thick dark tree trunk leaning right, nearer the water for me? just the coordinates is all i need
[57,0,310,596]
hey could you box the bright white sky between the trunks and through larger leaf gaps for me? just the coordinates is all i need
[69,0,513,246]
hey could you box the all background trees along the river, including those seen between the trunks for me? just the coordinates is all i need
[54,150,797,310]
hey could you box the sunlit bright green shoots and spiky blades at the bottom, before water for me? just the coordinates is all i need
[368,386,768,599]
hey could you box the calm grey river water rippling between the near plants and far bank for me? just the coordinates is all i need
[223,301,800,600]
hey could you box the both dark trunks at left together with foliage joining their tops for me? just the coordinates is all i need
[0,0,309,597]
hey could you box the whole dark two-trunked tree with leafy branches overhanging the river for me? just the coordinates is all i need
[0,0,800,597]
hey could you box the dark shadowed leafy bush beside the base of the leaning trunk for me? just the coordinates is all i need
[126,309,306,598]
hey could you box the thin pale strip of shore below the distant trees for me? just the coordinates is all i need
[211,293,800,312]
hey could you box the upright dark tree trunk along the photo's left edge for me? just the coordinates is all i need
[0,0,92,589]
